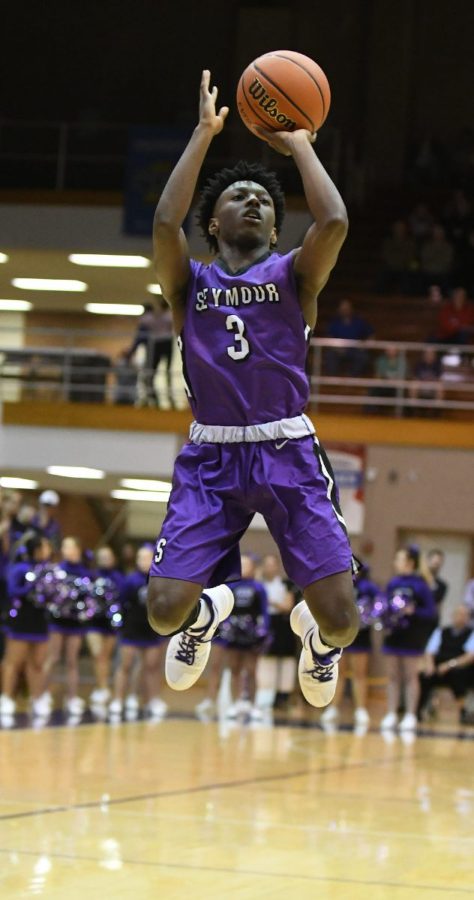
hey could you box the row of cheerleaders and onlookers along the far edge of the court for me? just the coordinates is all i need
[0,490,474,732]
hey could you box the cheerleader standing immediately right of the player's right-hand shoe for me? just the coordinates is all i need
[320,565,381,732]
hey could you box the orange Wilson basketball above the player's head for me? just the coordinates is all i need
[237,50,331,137]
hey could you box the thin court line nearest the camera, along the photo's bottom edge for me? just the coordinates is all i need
[0,847,474,896]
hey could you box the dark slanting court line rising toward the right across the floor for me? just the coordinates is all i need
[0,755,438,822]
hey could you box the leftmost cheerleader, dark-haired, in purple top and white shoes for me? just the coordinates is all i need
[0,533,51,716]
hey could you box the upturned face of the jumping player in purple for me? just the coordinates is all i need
[209,181,276,247]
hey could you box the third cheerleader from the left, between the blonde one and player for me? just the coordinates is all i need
[87,547,125,706]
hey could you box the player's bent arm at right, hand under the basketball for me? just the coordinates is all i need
[256,129,348,328]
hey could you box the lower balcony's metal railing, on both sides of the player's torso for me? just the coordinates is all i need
[0,328,474,418]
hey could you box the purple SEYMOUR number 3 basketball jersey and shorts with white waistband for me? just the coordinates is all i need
[150,252,352,588]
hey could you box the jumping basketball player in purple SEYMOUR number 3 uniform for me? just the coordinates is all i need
[148,70,358,706]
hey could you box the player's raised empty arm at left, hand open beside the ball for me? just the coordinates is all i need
[153,69,229,322]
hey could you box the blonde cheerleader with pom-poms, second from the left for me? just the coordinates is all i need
[46,536,90,716]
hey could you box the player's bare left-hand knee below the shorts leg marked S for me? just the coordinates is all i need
[147,577,201,636]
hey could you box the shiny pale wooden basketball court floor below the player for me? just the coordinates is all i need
[0,716,474,900]
